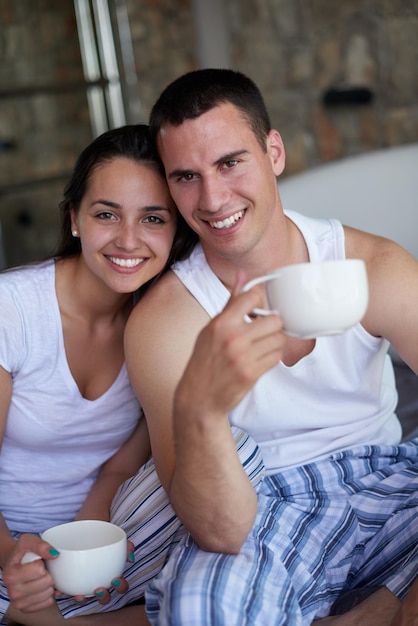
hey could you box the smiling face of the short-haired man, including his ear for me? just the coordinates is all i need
[158,103,284,259]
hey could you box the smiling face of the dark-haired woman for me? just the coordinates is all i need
[71,157,177,293]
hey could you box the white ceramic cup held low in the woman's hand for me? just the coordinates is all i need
[41,520,127,596]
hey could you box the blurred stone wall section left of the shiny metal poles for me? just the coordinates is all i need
[0,0,92,265]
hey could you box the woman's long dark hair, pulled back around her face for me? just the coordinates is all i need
[54,124,197,267]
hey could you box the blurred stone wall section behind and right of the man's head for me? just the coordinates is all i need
[227,0,418,173]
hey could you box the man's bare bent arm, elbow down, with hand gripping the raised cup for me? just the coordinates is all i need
[125,274,282,553]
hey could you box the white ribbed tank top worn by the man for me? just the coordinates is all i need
[173,211,401,474]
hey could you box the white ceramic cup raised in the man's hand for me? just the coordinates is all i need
[242,259,369,339]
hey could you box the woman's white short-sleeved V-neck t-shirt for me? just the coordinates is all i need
[0,260,140,532]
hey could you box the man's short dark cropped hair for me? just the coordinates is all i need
[149,69,271,151]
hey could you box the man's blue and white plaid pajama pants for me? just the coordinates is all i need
[146,439,418,626]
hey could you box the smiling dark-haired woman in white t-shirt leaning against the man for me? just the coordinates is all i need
[0,125,194,626]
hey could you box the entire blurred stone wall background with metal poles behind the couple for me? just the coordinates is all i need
[0,0,418,267]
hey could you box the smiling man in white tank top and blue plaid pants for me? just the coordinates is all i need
[125,70,418,626]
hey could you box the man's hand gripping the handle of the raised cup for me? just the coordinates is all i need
[175,276,286,419]
